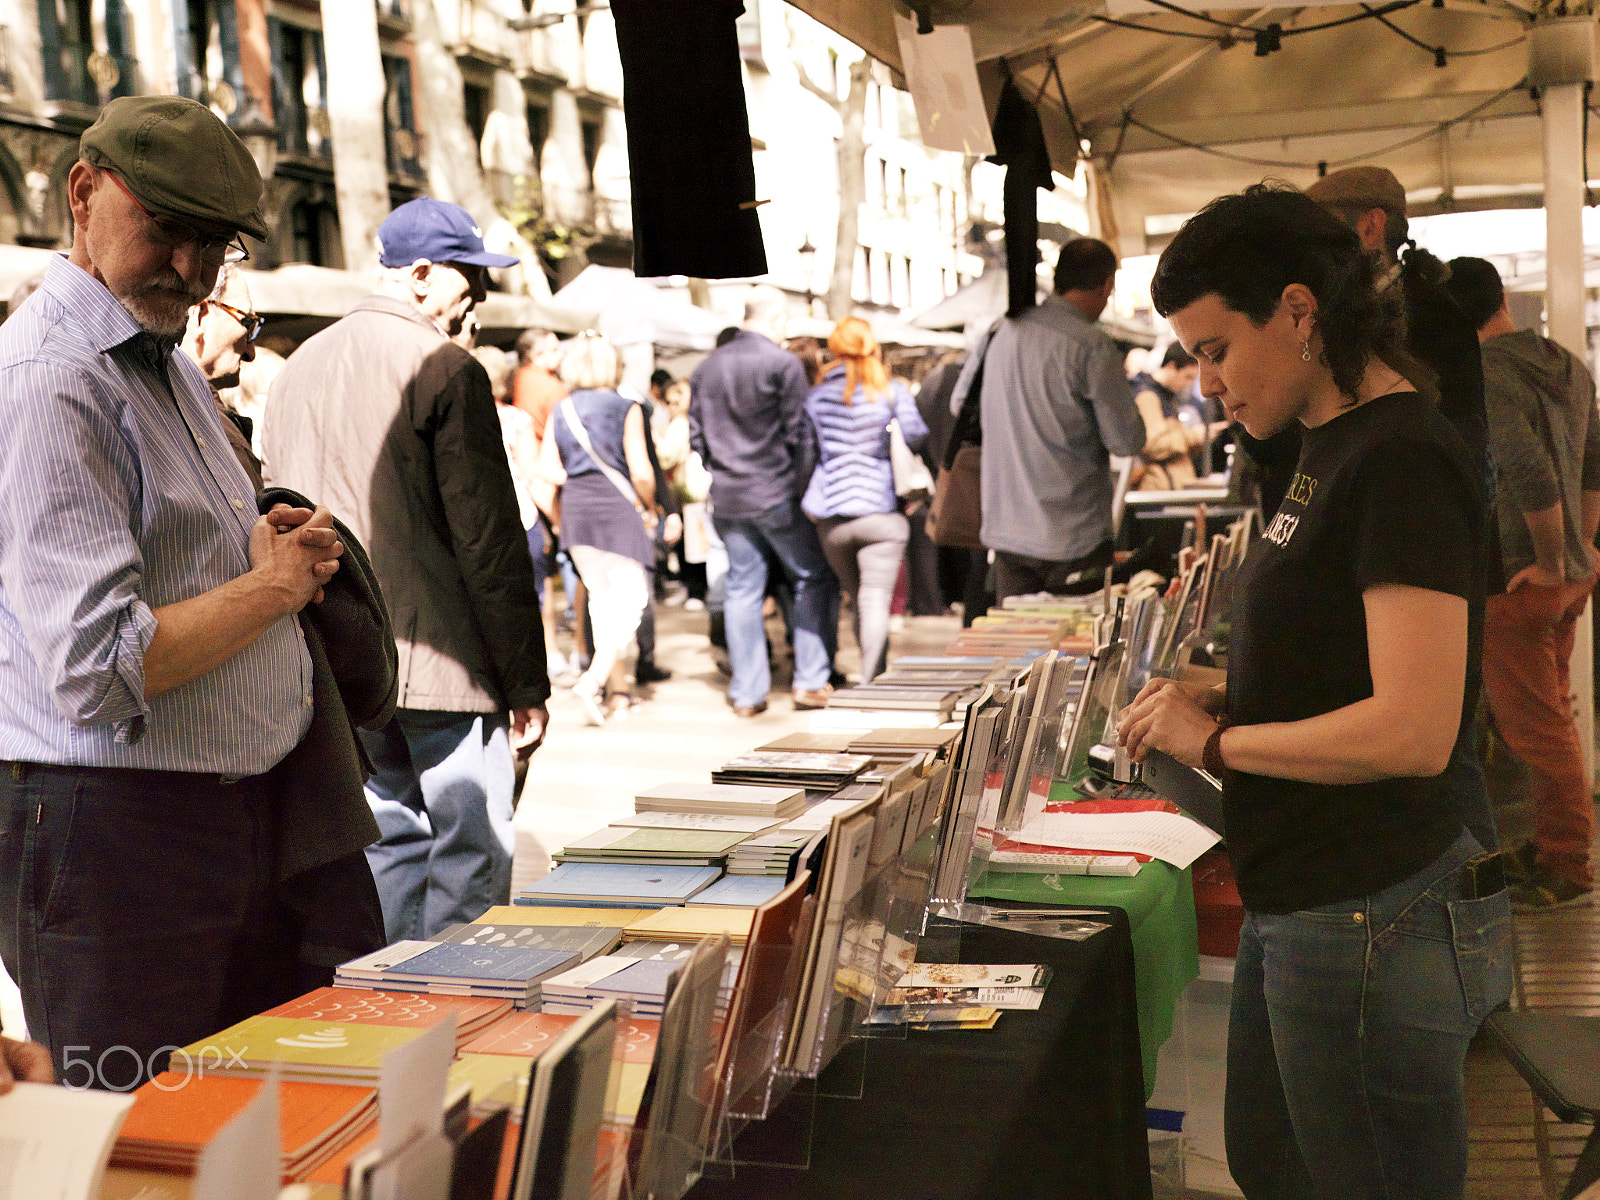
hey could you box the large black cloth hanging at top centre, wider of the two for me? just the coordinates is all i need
[611,0,766,278]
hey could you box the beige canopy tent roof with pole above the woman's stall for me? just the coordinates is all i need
[790,0,1595,774]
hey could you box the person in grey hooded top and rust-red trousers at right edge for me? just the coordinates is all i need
[1446,258,1600,910]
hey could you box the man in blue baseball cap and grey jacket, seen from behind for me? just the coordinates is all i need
[264,197,550,941]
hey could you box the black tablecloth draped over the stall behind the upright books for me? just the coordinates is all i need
[690,906,1150,1200]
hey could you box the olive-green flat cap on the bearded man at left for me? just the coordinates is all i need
[78,96,269,238]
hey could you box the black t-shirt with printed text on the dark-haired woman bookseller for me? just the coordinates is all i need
[1224,392,1485,912]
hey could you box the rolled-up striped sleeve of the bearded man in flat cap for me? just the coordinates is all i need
[0,362,157,742]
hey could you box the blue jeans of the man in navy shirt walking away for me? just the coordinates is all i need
[712,501,838,707]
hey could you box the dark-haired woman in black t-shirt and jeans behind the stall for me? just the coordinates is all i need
[1120,187,1509,1200]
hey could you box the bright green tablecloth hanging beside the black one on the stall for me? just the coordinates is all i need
[966,861,1200,1099]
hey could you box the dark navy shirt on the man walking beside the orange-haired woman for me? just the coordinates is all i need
[690,330,816,517]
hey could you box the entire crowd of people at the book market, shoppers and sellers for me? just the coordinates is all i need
[0,98,1600,1197]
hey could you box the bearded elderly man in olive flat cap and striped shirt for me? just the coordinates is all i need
[0,96,370,1091]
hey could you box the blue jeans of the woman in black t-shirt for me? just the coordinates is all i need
[1224,832,1510,1200]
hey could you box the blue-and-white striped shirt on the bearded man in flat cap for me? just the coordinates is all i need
[0,258,312,774]
